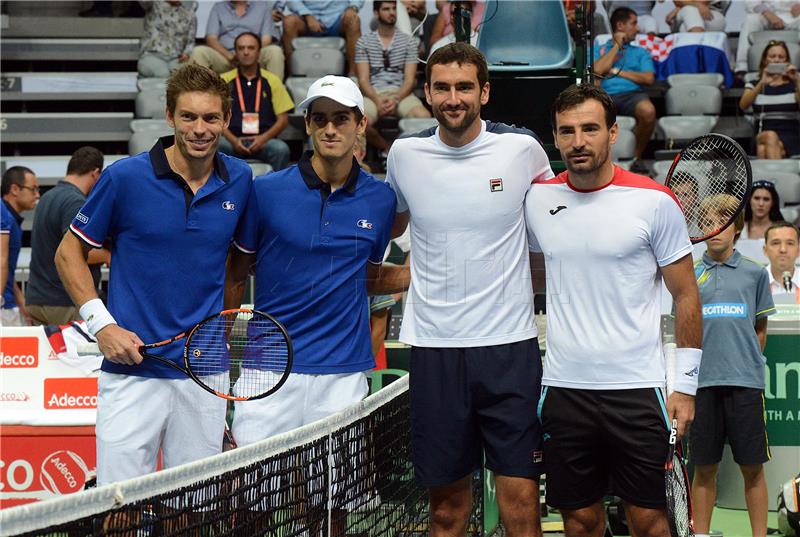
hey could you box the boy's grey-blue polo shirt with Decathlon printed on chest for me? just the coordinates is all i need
[694,250,775,390]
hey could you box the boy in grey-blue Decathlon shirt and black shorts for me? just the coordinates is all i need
[689,194,775,537]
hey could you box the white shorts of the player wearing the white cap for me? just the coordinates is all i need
[231,371,369,446]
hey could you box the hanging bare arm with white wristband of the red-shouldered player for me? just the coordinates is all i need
[661,254,703,437]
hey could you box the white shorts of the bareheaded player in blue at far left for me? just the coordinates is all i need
[97,371,227,485]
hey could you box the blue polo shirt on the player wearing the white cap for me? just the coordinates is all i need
[235,153,397,374]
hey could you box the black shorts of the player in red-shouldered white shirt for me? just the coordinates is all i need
[539,386,669,510]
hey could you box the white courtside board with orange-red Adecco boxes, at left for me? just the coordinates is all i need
[0,326,97,426]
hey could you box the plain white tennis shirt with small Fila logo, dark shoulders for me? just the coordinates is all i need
[386,122,553,347]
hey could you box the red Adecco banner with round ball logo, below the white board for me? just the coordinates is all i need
[0,428,96,509]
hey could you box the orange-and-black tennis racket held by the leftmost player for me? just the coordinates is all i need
[78,309,293,401]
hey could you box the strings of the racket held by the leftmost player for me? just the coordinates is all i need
[186,311,289,398]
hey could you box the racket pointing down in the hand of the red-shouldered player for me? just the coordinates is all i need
[664,419,694,537]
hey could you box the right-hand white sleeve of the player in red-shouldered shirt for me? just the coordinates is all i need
[650,191,692,267]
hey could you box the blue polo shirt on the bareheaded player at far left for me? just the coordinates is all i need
[70,136,252,378]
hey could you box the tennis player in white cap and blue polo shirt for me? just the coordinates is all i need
[226,76,409,445]
